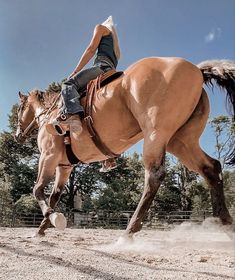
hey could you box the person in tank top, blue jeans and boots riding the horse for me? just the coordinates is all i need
[47,16,120,135]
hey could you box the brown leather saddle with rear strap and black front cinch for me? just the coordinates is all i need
[65,69,123,164]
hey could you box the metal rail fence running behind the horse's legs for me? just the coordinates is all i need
[0,210,215,229]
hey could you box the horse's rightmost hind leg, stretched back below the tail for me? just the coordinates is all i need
[167,92,232,224]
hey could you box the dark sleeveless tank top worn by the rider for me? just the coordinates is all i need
[97,33,118,68]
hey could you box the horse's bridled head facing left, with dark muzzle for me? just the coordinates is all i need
[15,92,37,143]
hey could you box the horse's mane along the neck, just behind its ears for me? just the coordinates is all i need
[29,89,60,109]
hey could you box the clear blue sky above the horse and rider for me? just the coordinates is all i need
[0,0,235,154]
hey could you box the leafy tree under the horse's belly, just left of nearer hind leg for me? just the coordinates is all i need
[93,153,144,211]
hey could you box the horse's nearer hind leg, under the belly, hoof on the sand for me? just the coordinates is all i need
[126,133,165,236]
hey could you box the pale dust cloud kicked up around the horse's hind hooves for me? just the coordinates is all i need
[95,218,235,256]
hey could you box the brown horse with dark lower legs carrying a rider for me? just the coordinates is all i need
[16,58,235,236]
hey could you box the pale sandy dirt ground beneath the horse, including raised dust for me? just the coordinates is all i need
[0,220,235,280]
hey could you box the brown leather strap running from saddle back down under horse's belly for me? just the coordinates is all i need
[84,69,119,158]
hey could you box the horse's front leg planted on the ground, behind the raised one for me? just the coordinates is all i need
[38,165,73,235]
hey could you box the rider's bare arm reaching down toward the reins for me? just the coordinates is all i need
[70,25,109,77]
